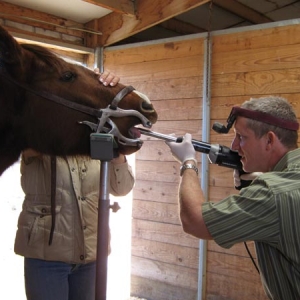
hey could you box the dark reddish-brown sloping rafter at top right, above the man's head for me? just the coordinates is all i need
[213,0,274,24]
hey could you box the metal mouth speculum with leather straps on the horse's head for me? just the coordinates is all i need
[0,70,152,148]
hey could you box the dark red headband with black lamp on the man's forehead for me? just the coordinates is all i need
[213,106,299,133]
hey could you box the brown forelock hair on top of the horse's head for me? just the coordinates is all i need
[21,44,63,69]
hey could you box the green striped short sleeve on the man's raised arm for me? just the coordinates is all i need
[202,181,279,248]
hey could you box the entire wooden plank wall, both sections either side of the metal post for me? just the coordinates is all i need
[104,19,300,300]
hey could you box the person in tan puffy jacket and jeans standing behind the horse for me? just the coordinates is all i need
[15,70,134,300]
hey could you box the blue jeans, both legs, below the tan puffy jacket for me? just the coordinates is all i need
[24,258,96,300]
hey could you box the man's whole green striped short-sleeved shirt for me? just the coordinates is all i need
[203,149,300,300]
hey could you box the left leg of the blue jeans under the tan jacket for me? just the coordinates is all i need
[24,258,72,300]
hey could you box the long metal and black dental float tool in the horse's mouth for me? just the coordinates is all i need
[138,128,243,170]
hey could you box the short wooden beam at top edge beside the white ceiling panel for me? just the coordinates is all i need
[83,0,135,16]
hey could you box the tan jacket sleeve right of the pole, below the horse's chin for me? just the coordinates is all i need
[110,162,135,196]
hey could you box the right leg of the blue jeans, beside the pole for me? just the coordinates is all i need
[69,262,96,300]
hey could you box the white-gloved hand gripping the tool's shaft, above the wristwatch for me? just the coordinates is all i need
[166,133,197,164]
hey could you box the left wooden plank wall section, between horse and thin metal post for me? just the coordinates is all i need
[104,39,203,300]
